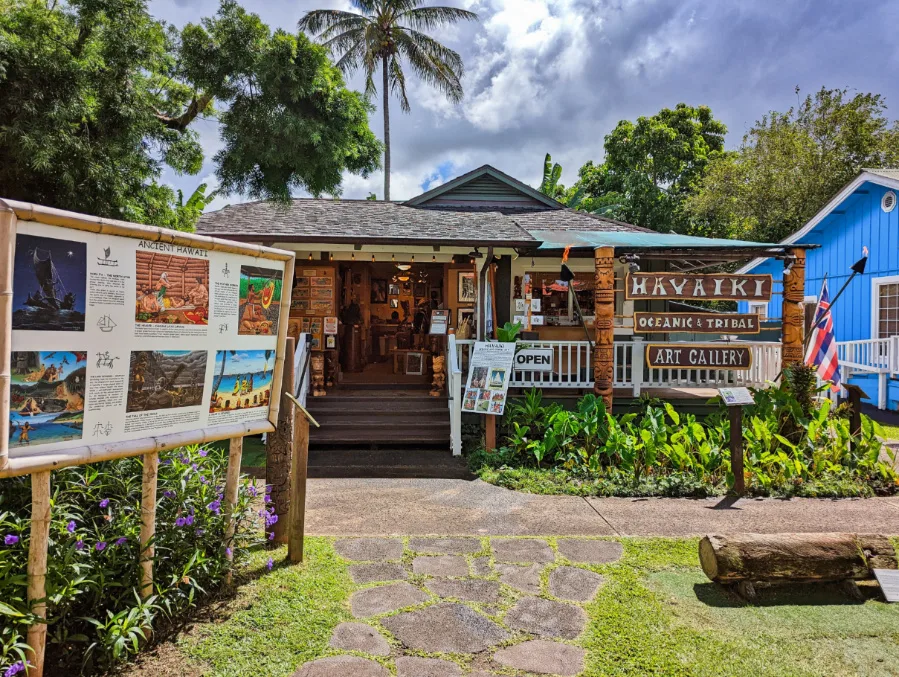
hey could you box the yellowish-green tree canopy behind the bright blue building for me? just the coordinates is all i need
[686,88,899,242]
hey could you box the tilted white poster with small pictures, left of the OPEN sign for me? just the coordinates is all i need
[462,341,515,416]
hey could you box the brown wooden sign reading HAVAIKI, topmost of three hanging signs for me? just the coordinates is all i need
[625,273,773,301]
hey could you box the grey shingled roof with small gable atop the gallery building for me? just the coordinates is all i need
[197,165,646,247]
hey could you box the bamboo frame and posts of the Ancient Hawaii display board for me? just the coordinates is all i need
[0,199,295,677]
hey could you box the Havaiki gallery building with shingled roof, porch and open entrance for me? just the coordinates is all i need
[197,165,805,453]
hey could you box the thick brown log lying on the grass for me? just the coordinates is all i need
[699,534,896,583]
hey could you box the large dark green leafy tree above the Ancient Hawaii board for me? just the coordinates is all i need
[0,0,381,228]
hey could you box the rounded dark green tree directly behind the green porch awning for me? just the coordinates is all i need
[571,103,727,232]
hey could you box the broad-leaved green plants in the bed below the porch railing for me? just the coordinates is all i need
[472,374,899,496]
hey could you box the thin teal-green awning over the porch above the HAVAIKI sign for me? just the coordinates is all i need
[530,230,778,249]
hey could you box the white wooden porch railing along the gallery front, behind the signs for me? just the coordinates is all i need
[455,337,781,397]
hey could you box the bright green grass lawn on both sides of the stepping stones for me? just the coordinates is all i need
[121,538,899,677]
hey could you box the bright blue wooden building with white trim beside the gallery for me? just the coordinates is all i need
[739,169,899,410]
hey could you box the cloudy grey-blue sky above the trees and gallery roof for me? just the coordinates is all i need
[150,0,899,209]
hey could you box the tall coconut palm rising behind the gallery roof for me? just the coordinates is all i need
[299,0,478,200]
